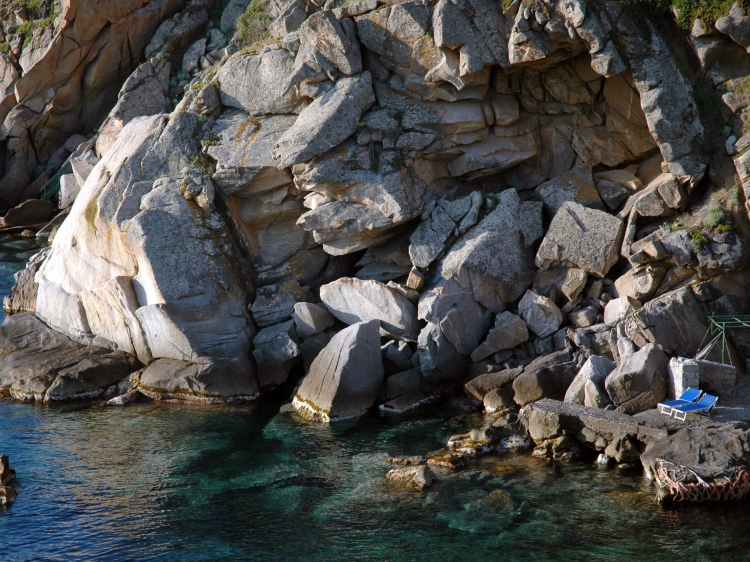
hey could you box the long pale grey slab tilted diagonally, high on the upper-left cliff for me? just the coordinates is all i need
[272,71,375,167]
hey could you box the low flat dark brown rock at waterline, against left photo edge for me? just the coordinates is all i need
[0,313,138,402]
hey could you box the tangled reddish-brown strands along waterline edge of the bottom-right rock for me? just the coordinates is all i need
[656,458,750,502]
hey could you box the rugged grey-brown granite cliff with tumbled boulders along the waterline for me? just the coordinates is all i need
[0,0,750,504]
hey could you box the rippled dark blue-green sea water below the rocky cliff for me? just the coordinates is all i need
[0,234,750,561]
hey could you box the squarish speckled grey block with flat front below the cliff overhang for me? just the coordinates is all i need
[536,201,624,277]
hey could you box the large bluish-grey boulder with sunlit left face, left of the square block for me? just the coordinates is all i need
[440,189,541,312]
